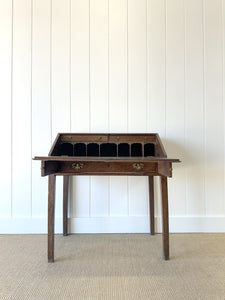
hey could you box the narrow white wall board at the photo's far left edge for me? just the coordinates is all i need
[0,0,12,217]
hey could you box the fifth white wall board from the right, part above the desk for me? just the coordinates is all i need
[128,0,147,132]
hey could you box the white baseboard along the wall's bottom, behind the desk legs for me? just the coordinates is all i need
[0,216,225,234]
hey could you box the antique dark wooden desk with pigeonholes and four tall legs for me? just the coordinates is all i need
[34,133,179,262]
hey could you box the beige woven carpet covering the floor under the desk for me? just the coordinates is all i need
[0,234,225,300]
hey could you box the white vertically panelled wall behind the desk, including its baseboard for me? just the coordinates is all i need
[0,0,225,233]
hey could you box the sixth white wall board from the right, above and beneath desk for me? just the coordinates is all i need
[109,0,128,215]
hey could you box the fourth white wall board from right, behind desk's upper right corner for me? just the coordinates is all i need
[147,0,166,216]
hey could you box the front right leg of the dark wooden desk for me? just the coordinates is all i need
[161,176,169,260]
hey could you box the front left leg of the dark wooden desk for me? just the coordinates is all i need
[48,175,55,262]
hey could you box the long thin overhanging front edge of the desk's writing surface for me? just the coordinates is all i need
[33,156,181,163]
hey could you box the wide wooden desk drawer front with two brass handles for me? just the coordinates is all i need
[59,161,157,174]
